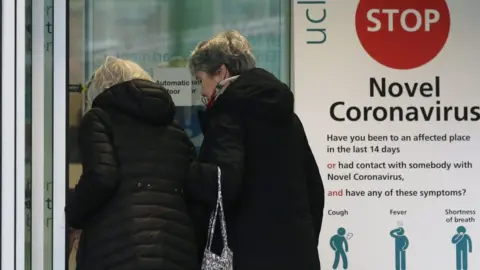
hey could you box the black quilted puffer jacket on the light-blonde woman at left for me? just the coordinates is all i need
[66,80,198,270]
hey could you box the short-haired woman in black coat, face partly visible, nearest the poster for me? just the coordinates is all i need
[186,31,324,270]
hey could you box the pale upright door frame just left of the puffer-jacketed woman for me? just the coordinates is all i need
[53,0,69,270]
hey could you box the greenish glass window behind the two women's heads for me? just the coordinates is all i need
[68,0,290,269]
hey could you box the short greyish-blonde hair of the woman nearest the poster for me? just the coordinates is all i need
[188,30,256,76]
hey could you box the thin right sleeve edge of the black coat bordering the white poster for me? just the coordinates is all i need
[297,115,325,242]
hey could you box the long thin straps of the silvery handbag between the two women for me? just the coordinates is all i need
[207,167,228,250]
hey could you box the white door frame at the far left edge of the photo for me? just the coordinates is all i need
[1,0,26,270]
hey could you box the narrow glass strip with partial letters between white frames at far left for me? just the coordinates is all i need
[27,0,53,270]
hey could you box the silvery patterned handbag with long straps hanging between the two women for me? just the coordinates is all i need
[202,168,233,270]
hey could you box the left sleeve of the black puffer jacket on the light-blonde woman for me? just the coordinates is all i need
[65,110,118,229]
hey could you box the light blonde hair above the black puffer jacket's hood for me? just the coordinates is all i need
[85,56,153,111]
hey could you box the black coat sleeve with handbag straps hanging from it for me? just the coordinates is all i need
[186,115,244,207]
